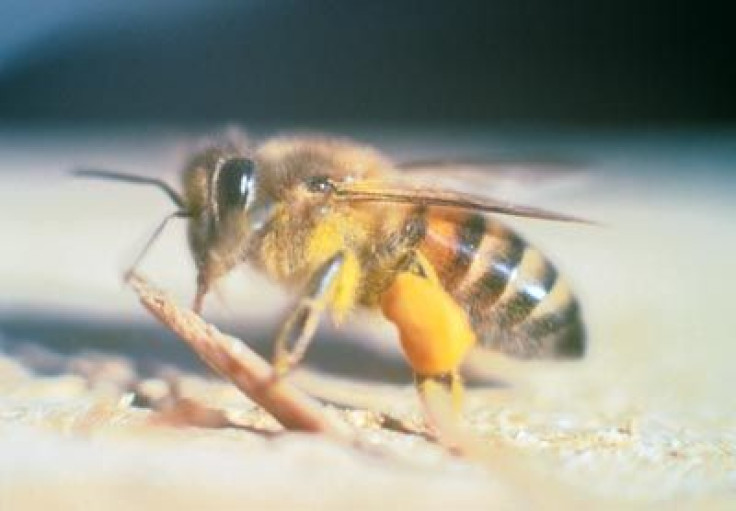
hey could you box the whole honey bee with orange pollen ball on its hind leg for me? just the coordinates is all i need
[76,136,586,412]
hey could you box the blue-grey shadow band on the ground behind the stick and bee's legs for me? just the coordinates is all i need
[0,313,412,384]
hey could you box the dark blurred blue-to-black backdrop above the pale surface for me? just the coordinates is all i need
[0,0,736,125]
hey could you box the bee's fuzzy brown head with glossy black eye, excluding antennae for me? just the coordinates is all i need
[184,149,267,306]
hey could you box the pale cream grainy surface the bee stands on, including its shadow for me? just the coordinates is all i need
[0,127,736,509]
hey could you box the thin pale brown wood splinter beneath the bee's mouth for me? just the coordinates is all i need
[129,274,349,441]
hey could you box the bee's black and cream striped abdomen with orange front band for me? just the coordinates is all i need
[419,213,585,358]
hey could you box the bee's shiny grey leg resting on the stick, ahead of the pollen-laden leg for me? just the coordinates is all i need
[273,252,345,376]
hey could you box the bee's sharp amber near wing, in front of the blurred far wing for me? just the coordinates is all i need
[335,181,594,224]
